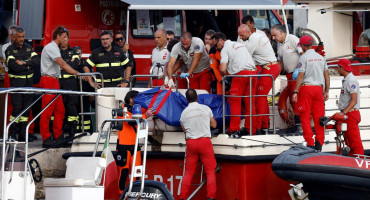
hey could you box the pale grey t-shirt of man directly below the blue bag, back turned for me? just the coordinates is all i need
[180,102,213,139]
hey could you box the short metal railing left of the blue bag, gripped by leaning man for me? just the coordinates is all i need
[77,72,104,132]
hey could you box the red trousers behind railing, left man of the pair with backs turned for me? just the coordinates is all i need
[227,70,257,134]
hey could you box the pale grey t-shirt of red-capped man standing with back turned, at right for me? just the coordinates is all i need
[298,49,328,87]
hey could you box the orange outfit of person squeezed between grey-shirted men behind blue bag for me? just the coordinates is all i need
[209,48,222,95]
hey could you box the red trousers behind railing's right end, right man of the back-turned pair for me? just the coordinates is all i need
[255,64,280,129]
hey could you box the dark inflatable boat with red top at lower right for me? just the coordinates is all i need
[272,145,370,200]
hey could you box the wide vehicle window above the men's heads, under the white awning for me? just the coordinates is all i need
[130,10,182,38]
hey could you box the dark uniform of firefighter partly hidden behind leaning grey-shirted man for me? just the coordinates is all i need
[59,46,80,137]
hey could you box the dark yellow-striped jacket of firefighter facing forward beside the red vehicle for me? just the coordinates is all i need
[87,46,131,87]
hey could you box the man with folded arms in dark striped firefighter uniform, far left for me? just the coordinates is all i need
[5,27,40,141]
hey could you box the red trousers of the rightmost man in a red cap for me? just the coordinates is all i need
[343,110,364,156]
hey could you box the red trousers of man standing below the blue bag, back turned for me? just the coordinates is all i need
[180,137,217,199]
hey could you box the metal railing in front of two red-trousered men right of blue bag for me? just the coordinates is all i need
[222,74,276,134]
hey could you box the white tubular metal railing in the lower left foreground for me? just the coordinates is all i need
[0,88,104,199]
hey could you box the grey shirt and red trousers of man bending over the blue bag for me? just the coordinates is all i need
[171,37,212,93]
